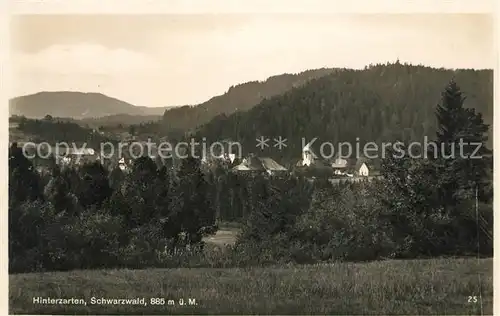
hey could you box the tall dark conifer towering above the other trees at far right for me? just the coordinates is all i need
[431,80,491,206]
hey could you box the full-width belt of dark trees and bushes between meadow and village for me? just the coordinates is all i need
[9,82,493,272]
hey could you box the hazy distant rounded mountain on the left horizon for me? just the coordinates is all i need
[9,91,167,119]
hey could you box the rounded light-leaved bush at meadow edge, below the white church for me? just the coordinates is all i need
[293,182,399,261]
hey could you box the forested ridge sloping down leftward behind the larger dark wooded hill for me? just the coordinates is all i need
[162,68,335,130]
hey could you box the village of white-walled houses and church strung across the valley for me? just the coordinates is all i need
[11,141,378,183]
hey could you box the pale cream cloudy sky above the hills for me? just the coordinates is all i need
[10,14,495,107]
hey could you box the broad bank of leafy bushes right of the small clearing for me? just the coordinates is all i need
[232,177,493,265]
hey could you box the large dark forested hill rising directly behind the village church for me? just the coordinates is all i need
[196,63,493,162]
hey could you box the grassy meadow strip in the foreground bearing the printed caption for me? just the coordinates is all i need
[9,259,493,315]
